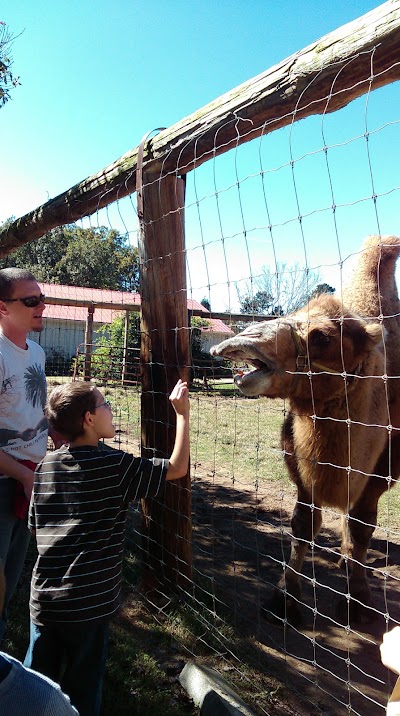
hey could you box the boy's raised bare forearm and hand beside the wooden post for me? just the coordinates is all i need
[166,380,189,480]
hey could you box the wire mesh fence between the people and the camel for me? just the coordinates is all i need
[5,9,400,716]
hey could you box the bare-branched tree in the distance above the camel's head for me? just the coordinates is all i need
[236,262,322,316]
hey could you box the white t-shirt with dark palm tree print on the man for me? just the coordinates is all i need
[0,333,47,468]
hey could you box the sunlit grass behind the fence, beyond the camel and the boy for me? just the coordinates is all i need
[88,381,400,531]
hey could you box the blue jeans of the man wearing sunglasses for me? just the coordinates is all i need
[0,477,31,642]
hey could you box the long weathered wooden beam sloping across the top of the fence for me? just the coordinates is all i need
[0,0,400,256]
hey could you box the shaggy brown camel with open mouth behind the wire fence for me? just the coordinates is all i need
[211,236,400,624]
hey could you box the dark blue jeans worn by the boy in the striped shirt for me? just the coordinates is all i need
[24,622,109,716]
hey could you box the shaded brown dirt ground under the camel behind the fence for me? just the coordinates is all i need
[184,466,400,716]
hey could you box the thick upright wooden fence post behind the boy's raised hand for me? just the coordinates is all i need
[137,137,192,597]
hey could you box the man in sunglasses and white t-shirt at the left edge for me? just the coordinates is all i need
[0,268,48,642]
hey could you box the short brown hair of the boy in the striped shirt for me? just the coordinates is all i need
[47,381,96,440]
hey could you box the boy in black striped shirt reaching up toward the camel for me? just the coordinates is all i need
[25,380,189,716]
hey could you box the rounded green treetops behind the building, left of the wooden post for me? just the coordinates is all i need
[0,219,139,291]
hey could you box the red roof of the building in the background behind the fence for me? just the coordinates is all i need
[39,282,233,334]
